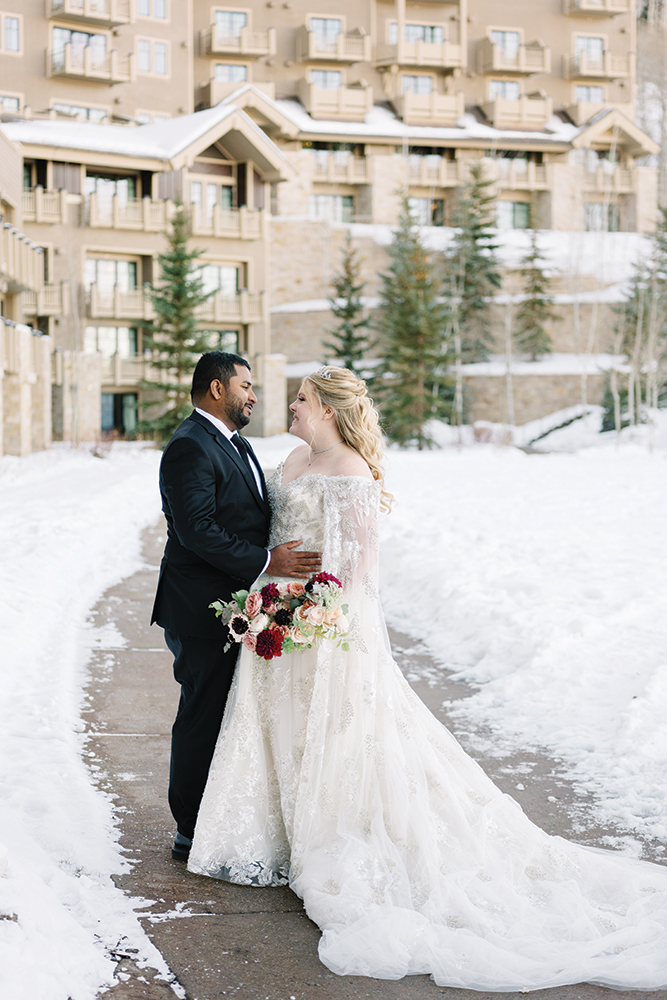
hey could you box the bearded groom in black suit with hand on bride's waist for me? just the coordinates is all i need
[151,351,320,861]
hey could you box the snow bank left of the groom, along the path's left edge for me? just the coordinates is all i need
[0,445,167,1000]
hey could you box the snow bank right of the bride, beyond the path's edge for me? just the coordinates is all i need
[382,442,667,838]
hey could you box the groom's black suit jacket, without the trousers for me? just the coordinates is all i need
[151,412,271,641]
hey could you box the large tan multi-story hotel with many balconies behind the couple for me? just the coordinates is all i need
[0,0,657,429]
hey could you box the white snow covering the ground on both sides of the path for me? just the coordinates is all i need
[0,424,667,1000]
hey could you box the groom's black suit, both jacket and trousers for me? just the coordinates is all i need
[151,412,271,837]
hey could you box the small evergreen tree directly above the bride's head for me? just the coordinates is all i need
[324,233,371,375]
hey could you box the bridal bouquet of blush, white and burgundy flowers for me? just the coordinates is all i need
[209,573,349,661]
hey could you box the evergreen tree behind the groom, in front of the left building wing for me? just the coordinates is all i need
[139,205,211,442]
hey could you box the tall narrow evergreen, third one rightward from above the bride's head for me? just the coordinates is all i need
[445,161,500,361]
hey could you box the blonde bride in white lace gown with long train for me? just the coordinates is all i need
[188,367,667,991]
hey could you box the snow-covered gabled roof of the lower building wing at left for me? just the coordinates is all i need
[0,104,294,181]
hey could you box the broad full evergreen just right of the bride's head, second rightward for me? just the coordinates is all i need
[376,201,452,450]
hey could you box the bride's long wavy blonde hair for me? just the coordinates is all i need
[301,365,394,512]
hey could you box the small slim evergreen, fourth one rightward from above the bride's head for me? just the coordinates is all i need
[515,213,560,361]
